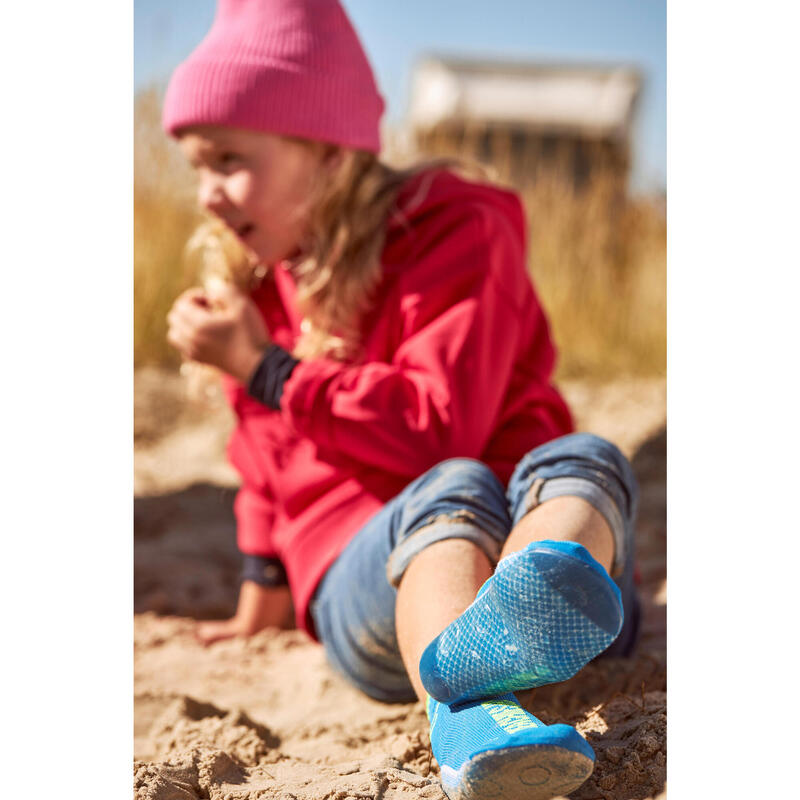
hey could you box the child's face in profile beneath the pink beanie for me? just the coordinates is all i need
[179,126,322,264]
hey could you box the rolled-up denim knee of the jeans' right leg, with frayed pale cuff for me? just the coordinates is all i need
[507,433,638,576]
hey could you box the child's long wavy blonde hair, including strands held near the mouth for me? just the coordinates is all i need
[188,145,489,361]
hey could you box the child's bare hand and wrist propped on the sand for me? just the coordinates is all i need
[195,580,293,644]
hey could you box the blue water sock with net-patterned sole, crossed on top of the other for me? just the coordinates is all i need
[419,540,622,703]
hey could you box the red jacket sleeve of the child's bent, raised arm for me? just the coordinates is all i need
[281,206,536,476]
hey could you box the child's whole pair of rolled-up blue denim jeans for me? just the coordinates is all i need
[311,433,640,702]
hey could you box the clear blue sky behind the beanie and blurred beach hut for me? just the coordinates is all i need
[134,0,667,190]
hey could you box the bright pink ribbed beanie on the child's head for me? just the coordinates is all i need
[162,0,384,153]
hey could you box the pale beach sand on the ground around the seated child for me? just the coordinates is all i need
[134,370,666,800]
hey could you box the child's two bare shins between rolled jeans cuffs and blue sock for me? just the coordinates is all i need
[395,495,614,701]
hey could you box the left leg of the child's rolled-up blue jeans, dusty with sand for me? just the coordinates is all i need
[311,458,511,702]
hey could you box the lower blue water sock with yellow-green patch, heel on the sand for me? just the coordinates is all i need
[427,694,594,800]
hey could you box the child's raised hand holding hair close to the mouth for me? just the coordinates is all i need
[167,284,269,384]
